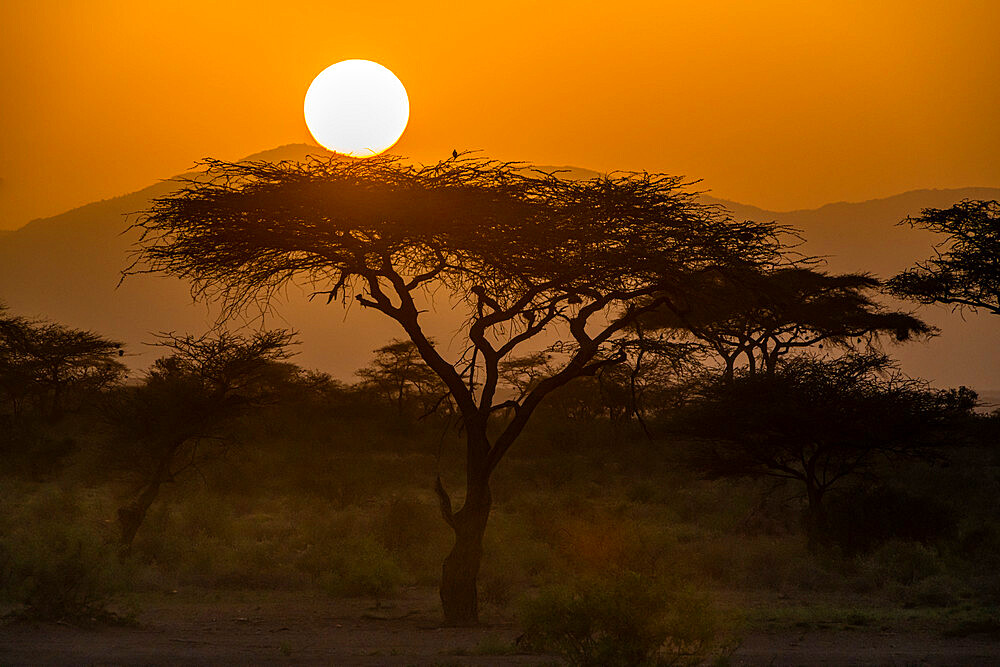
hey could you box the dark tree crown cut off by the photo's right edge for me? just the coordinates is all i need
[889,199,1000,315]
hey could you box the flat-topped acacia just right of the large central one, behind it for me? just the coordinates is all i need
[643,267,934,379]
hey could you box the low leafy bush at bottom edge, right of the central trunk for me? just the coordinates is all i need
[521,572,718,667]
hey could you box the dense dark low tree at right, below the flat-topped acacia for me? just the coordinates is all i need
[676,354,976,547]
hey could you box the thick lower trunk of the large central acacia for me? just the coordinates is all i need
[440,480,492,627]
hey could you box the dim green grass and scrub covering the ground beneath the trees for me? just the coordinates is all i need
[0,354,1000,640]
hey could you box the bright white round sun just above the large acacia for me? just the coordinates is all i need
[304,60,410,157]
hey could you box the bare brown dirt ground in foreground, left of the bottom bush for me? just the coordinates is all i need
[0,591,553,665]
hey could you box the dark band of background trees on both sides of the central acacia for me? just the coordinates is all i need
[0,282,994,553]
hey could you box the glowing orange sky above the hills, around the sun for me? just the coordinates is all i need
[0,0,1000,229]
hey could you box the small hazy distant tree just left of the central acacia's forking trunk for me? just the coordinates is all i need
[355,339,448,416]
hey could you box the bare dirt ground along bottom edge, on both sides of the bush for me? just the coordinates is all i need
[0,591,1000,665]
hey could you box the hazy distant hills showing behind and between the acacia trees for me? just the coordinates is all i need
[0,144,1000,390]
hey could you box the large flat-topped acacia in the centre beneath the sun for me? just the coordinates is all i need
[132,156,779,625]
